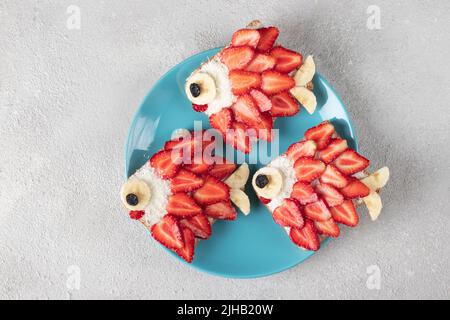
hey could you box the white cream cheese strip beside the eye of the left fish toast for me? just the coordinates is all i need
[133,163,172,226]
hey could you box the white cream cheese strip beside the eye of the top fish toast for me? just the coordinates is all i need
[200,58,236,117]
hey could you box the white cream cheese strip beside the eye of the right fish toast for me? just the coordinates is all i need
[267,155,297,212]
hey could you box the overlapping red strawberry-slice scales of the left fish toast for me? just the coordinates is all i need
[121,130,251,263]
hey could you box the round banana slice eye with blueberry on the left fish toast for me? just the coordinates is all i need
[120,179,151,210]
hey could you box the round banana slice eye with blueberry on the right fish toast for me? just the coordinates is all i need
[252,167,283,199]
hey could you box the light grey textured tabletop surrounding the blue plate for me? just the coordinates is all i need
[0,0,450,299]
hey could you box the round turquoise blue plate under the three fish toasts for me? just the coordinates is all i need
[125,48,356,278]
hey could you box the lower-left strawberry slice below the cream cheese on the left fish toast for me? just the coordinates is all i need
[150,215,184,249]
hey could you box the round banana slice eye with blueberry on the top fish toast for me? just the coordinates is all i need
[184,72,216,105]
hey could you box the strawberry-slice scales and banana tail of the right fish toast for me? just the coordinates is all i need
[253,121,389,251]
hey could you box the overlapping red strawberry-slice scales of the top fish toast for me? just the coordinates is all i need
[186,21,315,153]
